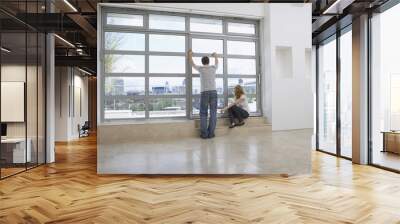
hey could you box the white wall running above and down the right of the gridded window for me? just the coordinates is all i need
[98,3,314,130]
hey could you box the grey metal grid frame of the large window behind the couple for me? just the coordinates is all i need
[99,6,262,122]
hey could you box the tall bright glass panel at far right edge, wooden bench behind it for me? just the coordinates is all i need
[370,4,400,172]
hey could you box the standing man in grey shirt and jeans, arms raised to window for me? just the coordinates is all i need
[188,50,218,139]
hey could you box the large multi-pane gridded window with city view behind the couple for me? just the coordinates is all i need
[101,8,261,120]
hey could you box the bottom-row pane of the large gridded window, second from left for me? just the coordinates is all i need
[149,98,186,117]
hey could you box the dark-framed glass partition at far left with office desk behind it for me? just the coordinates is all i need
[0,2,46,179]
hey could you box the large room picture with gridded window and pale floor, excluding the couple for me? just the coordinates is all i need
[97,3,313,174]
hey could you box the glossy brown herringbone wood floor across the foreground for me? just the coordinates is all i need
[0,134,400,224]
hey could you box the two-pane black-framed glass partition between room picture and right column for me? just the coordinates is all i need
[316,26,352,158]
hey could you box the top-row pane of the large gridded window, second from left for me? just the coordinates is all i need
[149,15,185,31]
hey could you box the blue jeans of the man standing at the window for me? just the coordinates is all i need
[200,90,218,138]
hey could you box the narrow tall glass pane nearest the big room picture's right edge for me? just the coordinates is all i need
[318,38,336,153]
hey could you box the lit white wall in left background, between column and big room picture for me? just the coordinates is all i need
[55,67,89,141]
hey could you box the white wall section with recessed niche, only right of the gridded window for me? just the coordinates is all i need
[264,4,314,130]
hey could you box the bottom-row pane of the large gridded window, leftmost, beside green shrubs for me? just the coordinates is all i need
[104,96,146,119]
